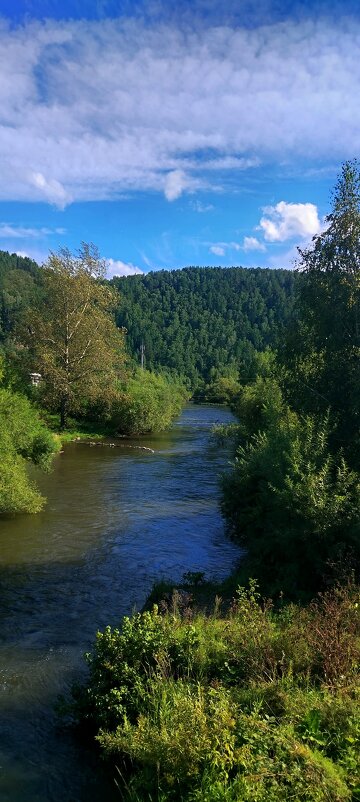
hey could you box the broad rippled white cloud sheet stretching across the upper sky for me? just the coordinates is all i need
[0,17,360,203]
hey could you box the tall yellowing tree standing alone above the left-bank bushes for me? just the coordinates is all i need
[27,243,125,428]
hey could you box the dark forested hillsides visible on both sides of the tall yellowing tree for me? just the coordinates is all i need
[0,252,296,400]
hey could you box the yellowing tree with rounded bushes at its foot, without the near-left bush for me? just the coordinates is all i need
[0,244,188,434]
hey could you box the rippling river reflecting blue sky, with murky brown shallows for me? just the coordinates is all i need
[0,406,238,802]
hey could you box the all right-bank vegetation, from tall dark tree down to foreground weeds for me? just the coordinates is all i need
[73,162,360,802]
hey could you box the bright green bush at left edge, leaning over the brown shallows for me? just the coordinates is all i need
[0,388,59,514]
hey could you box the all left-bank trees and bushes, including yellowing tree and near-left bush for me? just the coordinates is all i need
[0,244,188,514]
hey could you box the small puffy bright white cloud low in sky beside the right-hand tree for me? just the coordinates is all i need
[259,201,321,242]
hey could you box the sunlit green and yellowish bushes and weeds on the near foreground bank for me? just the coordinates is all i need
[75,582,360,802]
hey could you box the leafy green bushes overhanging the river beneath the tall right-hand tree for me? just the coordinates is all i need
[222,379,360,597]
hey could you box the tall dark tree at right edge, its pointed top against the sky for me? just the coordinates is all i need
[284,161,360,458]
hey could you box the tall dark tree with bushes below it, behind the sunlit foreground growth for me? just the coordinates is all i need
[222,163,360,598]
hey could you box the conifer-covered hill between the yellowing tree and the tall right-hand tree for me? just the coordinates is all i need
[112,267,296,385]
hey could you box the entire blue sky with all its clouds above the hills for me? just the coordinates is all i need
[0,0,360,275]
